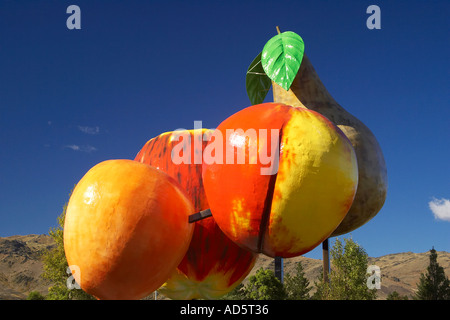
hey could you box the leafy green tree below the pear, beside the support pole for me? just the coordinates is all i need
[313,239,376,300]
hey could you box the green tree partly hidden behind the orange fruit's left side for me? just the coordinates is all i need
[42,204,94,300]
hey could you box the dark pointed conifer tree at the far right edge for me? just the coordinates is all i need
[415,248,450,300]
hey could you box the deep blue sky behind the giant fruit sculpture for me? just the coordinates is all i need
[0,0,450,258]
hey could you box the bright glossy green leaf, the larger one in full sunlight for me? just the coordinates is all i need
[261,31,305,90]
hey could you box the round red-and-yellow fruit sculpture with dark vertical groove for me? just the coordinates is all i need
[203,103,358,258]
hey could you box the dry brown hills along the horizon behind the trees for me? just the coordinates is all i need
[0,234,450,300]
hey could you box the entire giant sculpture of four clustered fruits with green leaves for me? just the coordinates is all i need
[64,28,387,299]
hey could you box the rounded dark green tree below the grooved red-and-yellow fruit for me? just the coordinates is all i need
[243,268,287,300]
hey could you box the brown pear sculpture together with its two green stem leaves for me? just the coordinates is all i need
[247,31,387,236]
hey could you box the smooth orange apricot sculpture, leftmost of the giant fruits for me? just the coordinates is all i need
[64,160,194,299]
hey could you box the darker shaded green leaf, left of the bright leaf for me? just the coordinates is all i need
[245,53,272,105]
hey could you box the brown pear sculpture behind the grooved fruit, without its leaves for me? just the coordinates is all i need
[272,55,387,237]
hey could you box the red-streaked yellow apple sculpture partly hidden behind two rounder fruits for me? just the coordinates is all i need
[135,129,257,299]
